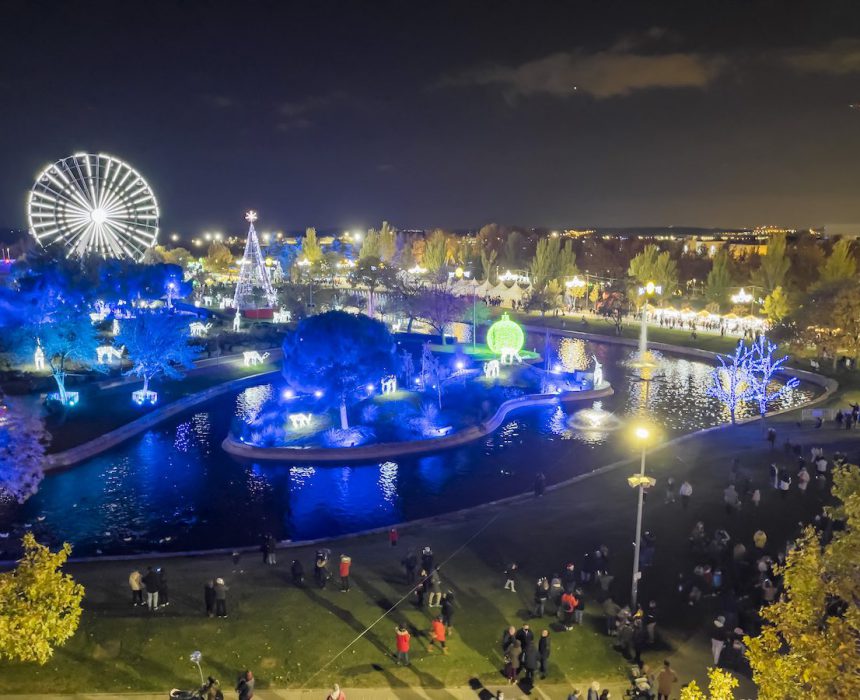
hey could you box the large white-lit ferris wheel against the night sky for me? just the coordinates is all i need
[27,153,158,260]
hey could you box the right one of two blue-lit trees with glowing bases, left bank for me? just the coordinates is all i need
[115,312,200,394]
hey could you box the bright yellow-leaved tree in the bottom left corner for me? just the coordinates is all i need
[0,532,84,664]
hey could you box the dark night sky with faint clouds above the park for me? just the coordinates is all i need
[5,0,860,233]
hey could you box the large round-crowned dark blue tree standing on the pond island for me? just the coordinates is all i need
[282,311,397,430]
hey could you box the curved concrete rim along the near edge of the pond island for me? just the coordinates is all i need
[221,386,614,463]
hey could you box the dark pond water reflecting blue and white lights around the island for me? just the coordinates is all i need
[0,343,813,558]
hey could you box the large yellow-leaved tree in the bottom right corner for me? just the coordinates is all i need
[744,466,860,700]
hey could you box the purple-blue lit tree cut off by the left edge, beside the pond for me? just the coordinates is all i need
[0,393,50,503]
